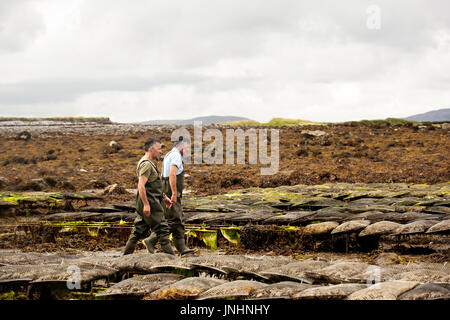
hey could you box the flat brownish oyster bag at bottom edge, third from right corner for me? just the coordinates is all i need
[292,283,367,300]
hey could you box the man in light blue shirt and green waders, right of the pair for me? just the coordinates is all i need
[147,137,197,255]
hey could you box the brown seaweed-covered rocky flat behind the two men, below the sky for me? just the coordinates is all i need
[0,122,450,194]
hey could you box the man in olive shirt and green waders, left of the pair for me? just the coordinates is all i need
[123,139,174,255]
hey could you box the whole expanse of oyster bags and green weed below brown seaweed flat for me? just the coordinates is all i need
[0,183,450,300]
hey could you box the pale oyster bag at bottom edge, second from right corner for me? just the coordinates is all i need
[347,281,419,300]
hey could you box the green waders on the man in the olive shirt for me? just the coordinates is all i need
[125,160,173,254]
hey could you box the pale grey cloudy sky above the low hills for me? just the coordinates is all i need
[0,0,450,122]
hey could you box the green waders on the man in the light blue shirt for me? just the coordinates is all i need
[149,171,197,255]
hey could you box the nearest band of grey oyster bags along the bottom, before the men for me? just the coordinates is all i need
[0,250,450,300]
